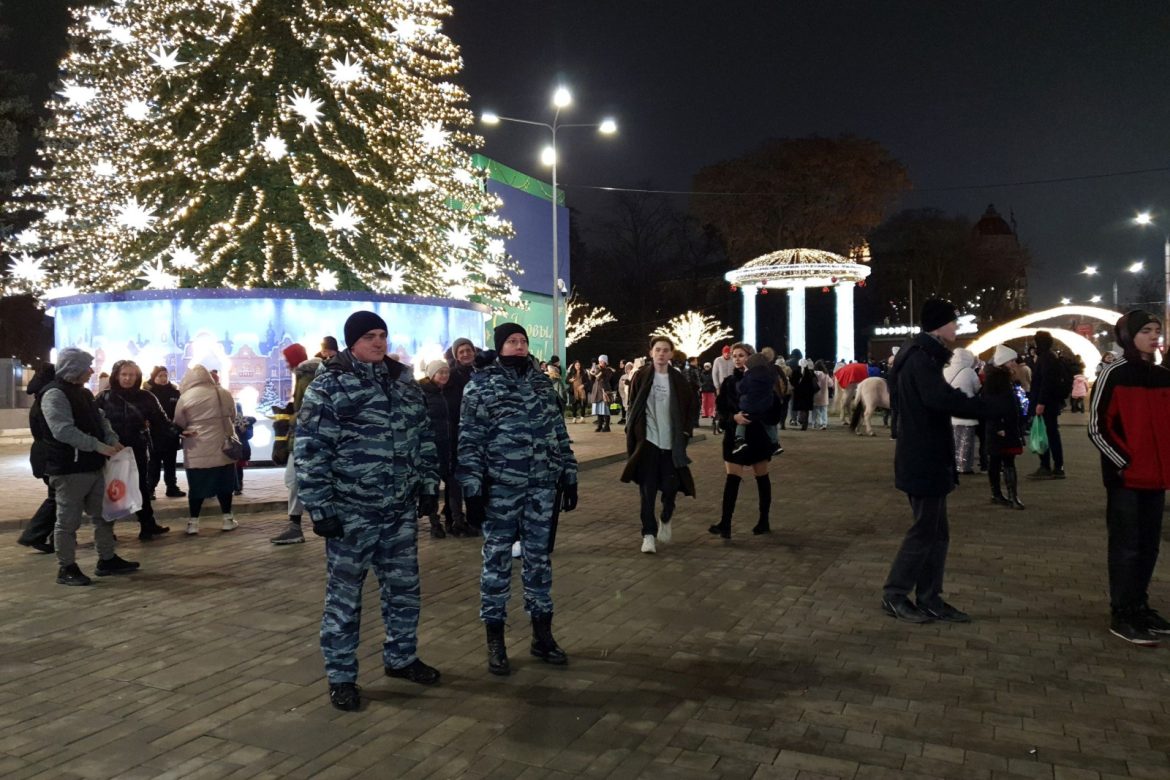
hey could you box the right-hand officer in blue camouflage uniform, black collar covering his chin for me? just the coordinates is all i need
[456,323,577,675]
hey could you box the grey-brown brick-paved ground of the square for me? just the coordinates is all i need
[0,411,1170,779]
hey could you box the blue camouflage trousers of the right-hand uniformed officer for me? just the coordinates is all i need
[480,484,556,621]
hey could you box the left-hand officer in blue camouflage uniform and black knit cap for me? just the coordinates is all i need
[294,311,439,710]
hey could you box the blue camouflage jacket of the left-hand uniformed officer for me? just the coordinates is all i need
[294,351,439,518]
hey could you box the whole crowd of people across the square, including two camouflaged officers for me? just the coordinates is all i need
[20,299,1170,710]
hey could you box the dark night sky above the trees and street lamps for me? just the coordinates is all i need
[2,0,1170,305]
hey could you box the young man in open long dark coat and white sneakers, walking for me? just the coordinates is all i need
[621,336,697,553]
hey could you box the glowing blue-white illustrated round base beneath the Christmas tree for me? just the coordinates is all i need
[53,289,490,461]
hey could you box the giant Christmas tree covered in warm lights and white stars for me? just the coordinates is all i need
[9,0,518,301]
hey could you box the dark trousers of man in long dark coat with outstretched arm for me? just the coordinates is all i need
[885,496,950,607]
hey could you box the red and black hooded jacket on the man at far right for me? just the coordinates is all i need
[1088,358,1170,490]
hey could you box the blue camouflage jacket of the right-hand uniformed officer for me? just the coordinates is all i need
[455,361,577,496]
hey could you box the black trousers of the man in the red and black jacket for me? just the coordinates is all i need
[1104,488,1166,613]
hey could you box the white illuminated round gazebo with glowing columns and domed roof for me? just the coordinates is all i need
[724,249,869,360]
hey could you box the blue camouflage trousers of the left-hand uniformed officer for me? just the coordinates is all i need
[321,505,420,683]
